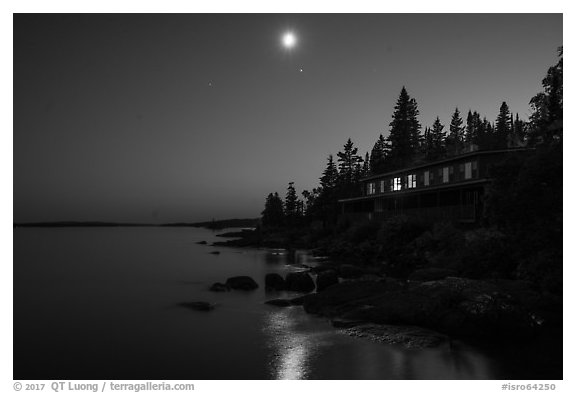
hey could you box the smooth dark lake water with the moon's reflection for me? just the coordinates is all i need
[14,228,561,380]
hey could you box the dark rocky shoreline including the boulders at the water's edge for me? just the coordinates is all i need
[189,233,562,348]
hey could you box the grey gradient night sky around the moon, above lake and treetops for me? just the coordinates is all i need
[14,14,562,222]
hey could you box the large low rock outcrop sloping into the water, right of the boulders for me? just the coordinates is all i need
[304,278,562,339]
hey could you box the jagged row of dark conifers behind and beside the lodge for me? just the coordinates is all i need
[262,47,563,227]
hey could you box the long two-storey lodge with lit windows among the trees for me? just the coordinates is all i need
[338,148,531,223]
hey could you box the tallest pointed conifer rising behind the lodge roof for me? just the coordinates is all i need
[386,87,420,169]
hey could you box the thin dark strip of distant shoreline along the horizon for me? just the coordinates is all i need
[13,218,260,229]
